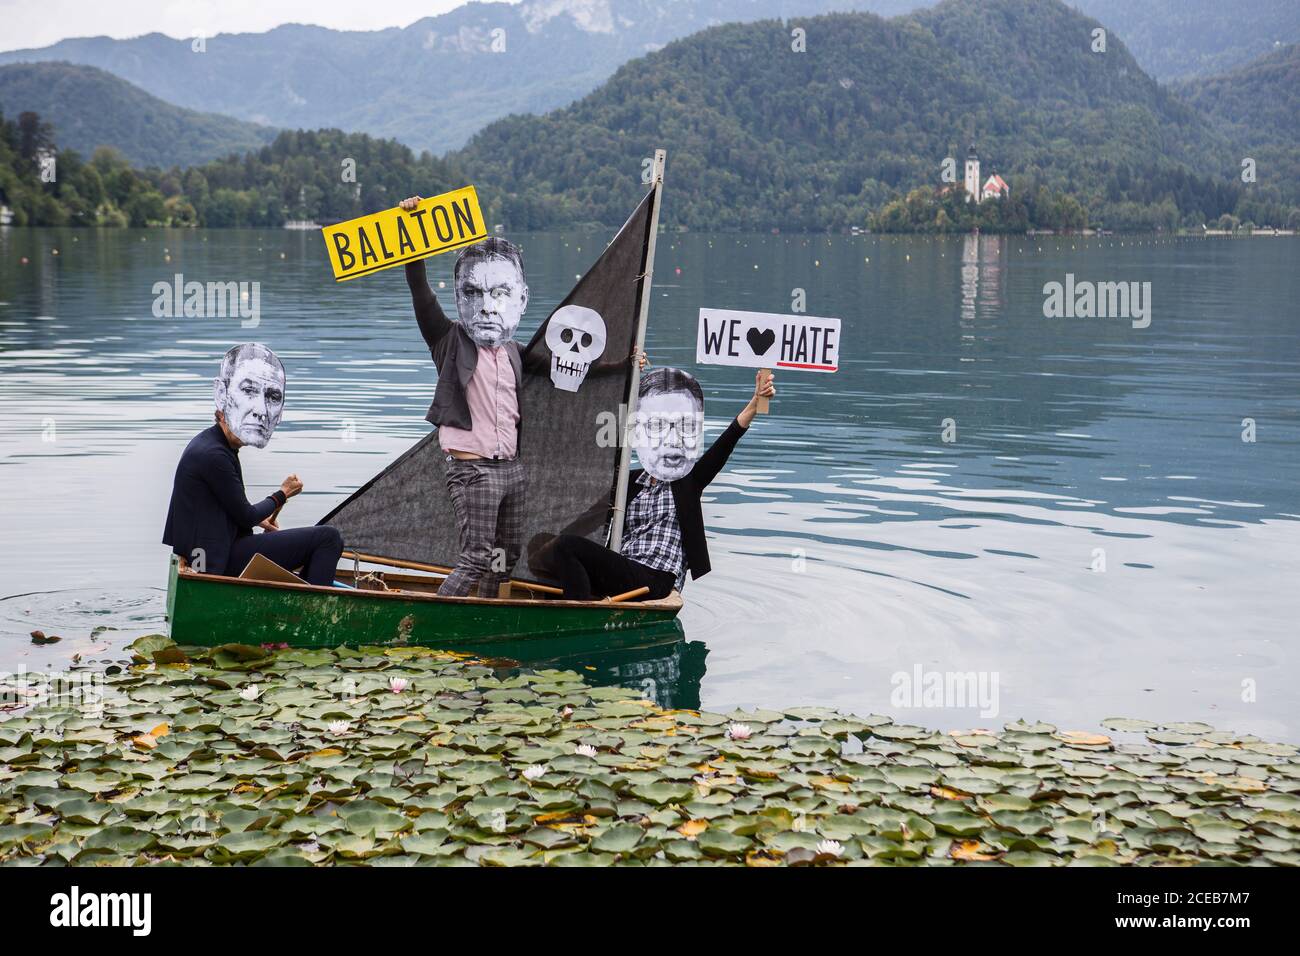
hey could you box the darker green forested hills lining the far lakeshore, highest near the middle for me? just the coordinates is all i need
[0,0,1300,232]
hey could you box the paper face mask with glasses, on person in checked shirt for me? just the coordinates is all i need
[633,368,705,481]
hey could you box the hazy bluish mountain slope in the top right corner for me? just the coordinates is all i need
[1070,0,1300,81]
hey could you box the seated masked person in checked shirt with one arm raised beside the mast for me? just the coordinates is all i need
[546,368,776,601]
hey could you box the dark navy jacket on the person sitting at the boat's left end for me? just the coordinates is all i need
[163,425,285,574]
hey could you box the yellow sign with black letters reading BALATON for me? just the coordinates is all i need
[321,186,488,282]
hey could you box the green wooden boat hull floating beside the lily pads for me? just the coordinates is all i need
[166,555,681,648]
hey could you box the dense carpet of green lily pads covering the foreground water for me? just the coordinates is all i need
[0,635,1300,866]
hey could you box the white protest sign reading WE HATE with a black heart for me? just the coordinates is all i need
[696,308,840,372]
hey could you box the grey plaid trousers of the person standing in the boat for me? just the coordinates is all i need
[438,455,528,597]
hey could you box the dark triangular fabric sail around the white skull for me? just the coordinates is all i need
[320,189,658,581]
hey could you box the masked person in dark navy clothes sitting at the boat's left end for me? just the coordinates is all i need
[163,342,343,585]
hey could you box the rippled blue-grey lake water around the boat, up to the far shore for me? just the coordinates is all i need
[0,229,1300,740]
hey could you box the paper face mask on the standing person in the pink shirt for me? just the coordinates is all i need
[455,238,528,347]
